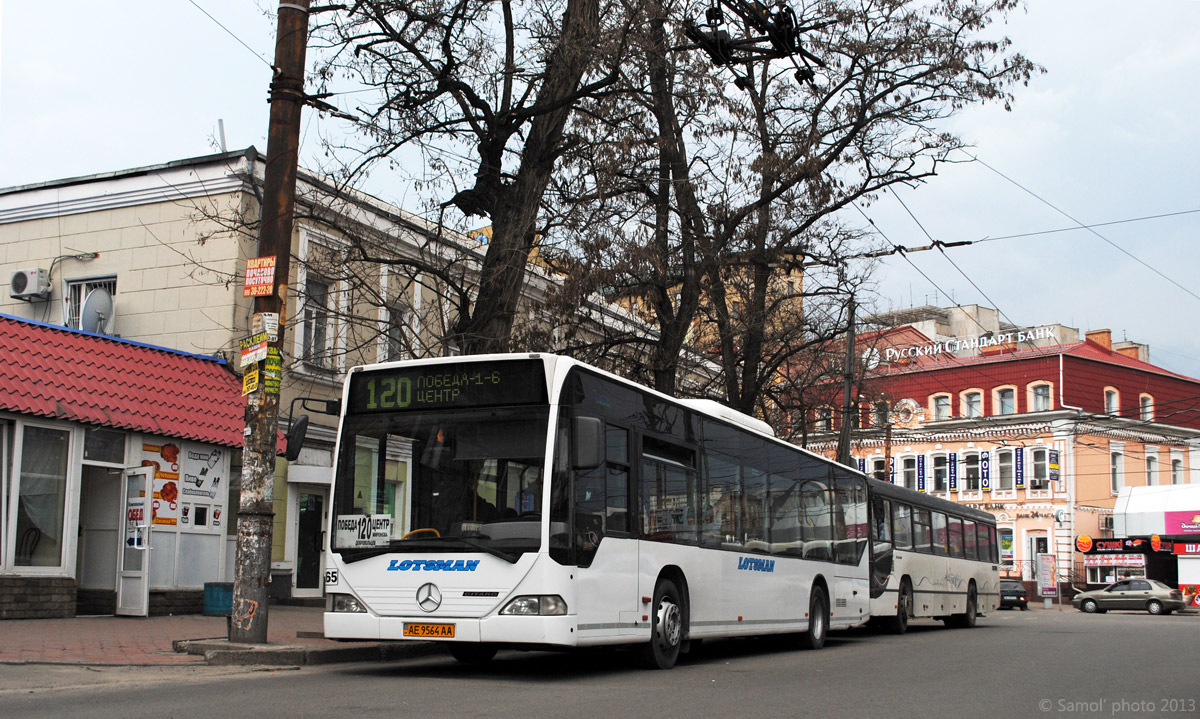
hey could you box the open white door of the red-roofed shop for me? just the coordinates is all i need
[116,467,154,617]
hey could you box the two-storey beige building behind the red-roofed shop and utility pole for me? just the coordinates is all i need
[0,148,626,598]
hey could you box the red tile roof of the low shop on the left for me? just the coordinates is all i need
[0,314,245,447]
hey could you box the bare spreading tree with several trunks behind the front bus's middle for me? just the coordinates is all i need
[549,0,1038,412]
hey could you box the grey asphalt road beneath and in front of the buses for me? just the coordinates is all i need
[0,609,1200,719]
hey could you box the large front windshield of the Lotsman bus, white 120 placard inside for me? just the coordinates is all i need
[330,405,550,562]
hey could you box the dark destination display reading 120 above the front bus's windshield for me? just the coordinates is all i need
[347,360,547,414]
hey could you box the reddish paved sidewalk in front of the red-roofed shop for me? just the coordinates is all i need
[0,605,440,666]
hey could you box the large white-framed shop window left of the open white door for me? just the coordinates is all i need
[5,424,78,568]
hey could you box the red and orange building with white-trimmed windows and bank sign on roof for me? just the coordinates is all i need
[810,306,1200,586]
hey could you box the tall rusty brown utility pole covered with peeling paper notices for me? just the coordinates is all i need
[229,0,310,643]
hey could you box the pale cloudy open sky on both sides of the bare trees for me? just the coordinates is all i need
[0,0,1200,377]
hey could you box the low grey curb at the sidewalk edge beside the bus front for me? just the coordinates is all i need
[172,639,444,666]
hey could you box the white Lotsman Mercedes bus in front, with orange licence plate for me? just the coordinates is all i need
[324,354,996,669]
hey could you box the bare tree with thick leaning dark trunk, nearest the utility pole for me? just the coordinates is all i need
[314,0,629,352]
